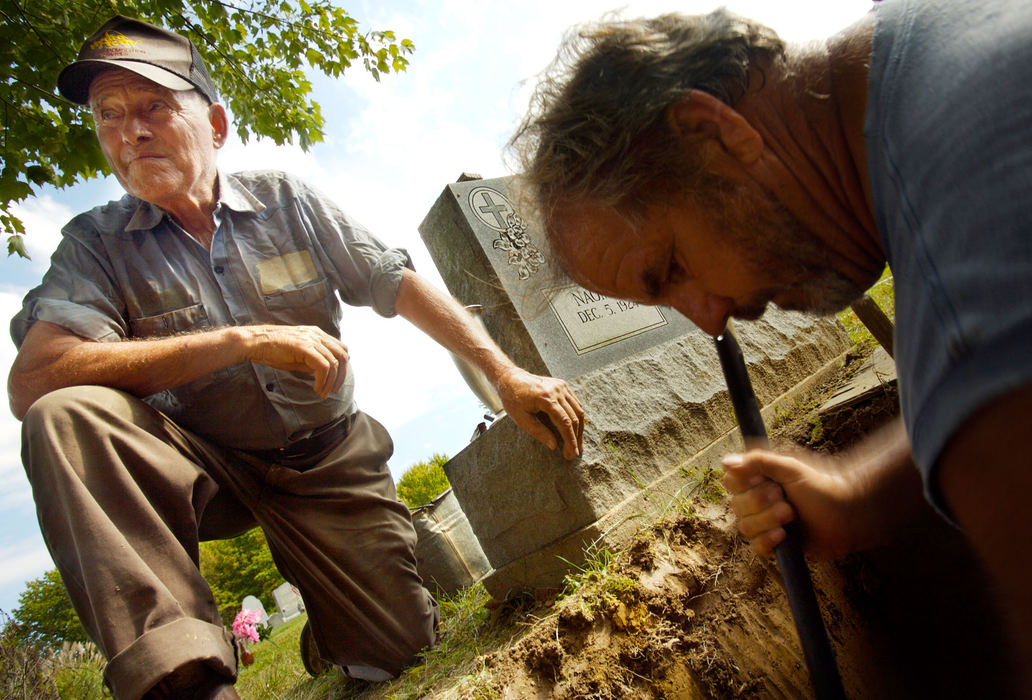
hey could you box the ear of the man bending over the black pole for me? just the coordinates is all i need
[667,90,764,165]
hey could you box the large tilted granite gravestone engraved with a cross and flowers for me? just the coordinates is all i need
[419,178,849,598]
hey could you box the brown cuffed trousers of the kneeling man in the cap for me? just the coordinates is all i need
[23,386,438,698]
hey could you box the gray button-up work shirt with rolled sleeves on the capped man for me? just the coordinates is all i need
[10,171,412,449]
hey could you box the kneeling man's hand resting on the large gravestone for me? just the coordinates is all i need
[496,367,584,459]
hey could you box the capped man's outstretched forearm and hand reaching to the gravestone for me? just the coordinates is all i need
[395,269,584,459]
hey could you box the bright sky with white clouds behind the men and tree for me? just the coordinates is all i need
[0,0,871,612]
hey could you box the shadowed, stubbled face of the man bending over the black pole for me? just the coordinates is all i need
[554,180,863,336]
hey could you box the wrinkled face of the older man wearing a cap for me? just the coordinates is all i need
[90,68,221,205]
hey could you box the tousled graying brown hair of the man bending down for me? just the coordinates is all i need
[509,8,785,229]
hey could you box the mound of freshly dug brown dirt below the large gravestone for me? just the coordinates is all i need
[478,515,825,699]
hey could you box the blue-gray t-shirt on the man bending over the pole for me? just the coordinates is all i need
[865,0,1032,512]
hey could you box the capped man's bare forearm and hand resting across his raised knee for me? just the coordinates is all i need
[7,321,348,420]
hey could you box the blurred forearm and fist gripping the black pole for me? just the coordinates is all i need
[723,420,924,559]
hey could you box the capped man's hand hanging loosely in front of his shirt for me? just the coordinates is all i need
[240,325,348,399]
